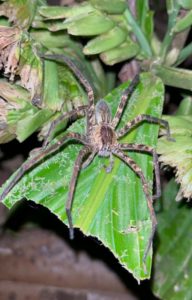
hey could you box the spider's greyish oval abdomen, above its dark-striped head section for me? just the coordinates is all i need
[95,100,111,124]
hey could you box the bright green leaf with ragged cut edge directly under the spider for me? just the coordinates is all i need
[0,73,164,281]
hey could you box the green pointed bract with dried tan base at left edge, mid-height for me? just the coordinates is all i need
[0,80,53,143]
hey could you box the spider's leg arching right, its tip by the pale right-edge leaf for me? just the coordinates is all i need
[117,114,174,141]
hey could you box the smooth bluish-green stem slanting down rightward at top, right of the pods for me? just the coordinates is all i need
[124,9,152,57]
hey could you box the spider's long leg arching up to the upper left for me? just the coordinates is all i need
[40,54,95,131]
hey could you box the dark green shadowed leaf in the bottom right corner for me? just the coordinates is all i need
[153,180,192,300]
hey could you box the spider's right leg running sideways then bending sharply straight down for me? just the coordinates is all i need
[118,144,161,200]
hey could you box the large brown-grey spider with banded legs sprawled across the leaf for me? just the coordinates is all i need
[0,54,171,261]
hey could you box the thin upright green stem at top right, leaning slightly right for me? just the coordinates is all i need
[160,0,179,61]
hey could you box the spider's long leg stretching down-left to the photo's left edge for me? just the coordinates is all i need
[0,132,86,200]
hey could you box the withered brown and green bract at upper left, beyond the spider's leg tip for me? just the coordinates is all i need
[0,26,42,99]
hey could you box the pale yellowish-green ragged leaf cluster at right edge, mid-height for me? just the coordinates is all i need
[157,98,192,200]
